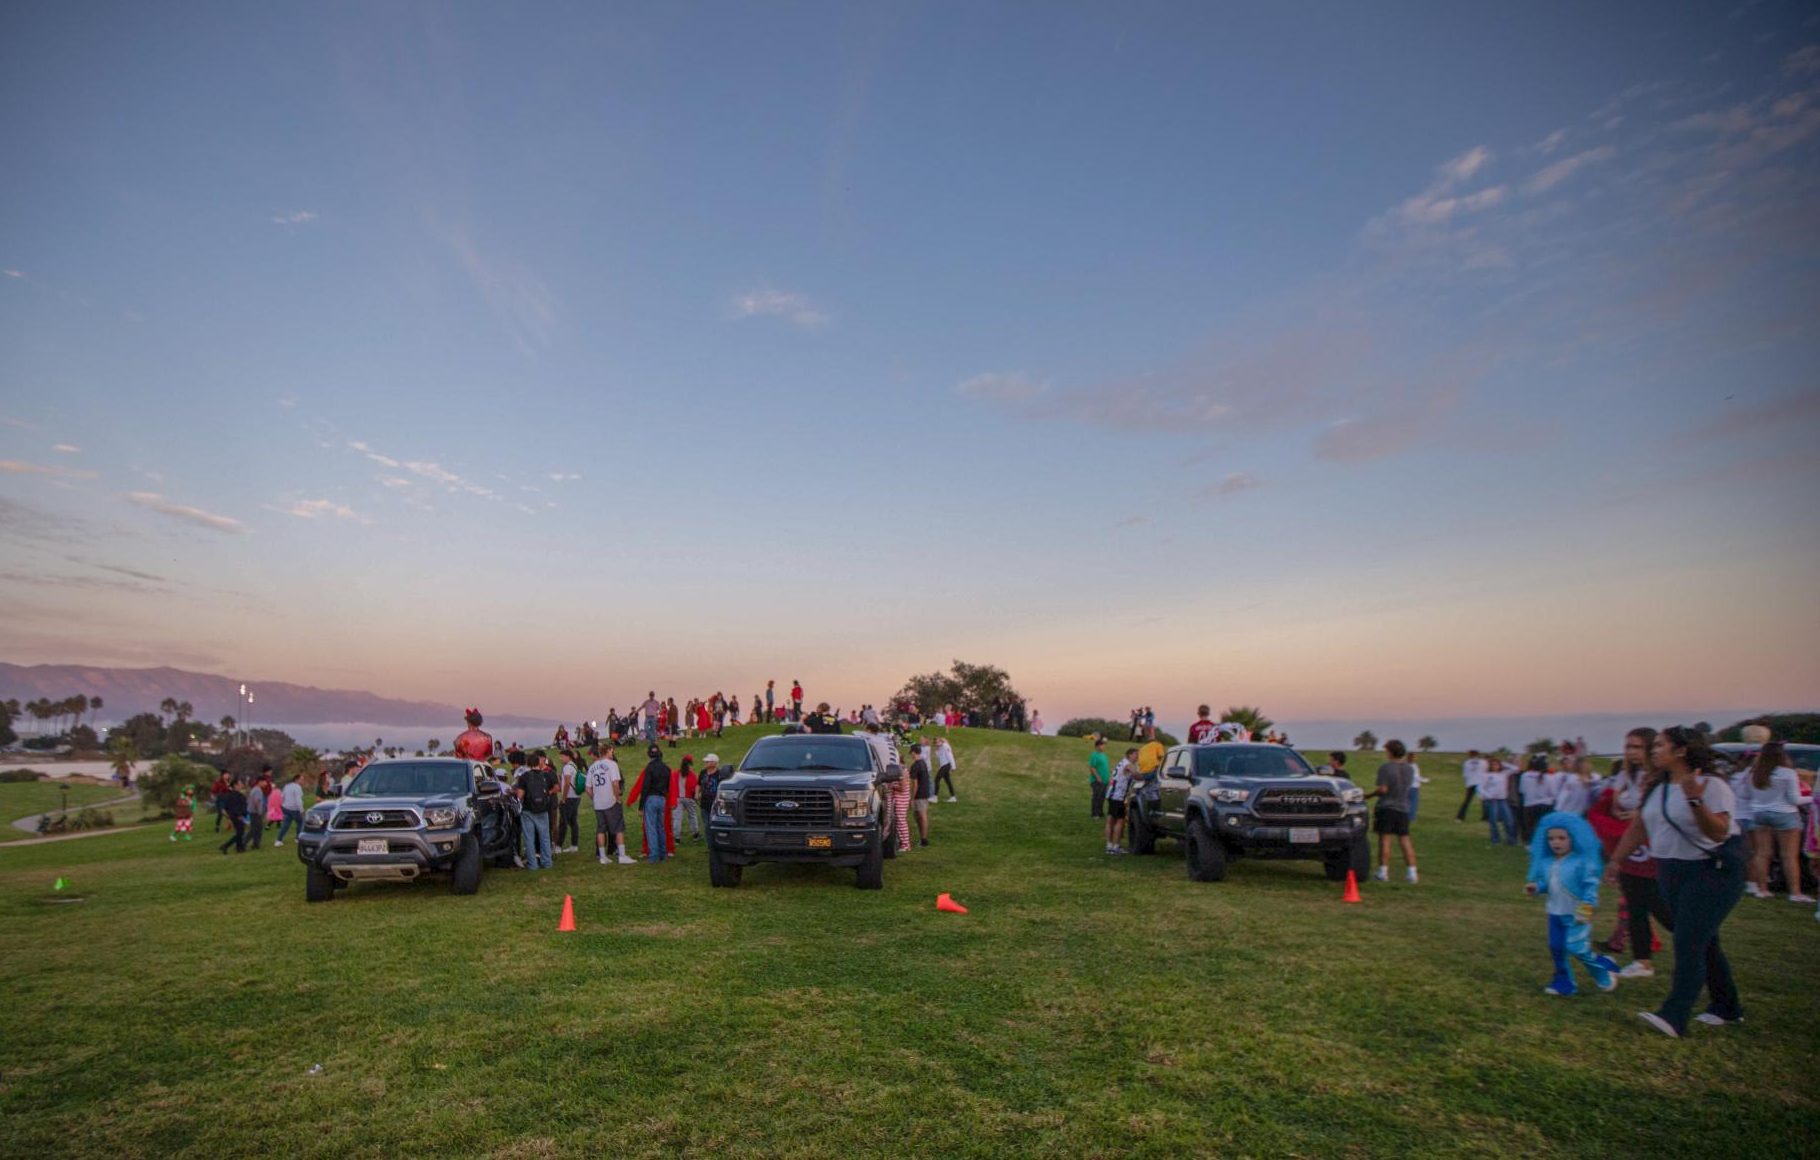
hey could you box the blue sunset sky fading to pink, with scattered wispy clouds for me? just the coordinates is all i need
[0,2,1820,723]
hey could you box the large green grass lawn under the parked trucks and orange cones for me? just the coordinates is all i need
[0,730,1820,1156]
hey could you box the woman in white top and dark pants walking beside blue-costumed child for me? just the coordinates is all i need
[1605,725,1745,1038]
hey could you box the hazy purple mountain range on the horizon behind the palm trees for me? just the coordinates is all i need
[0,661,555,734]
